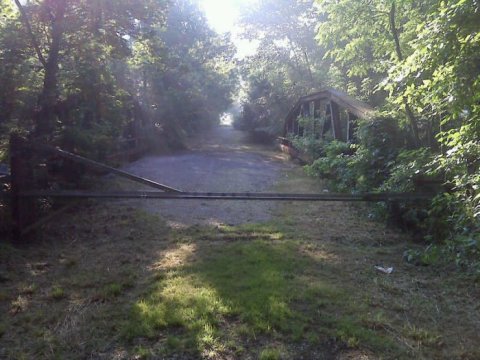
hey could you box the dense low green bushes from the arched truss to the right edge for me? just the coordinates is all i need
[305,113,480,271]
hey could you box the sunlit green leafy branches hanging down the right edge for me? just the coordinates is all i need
[386,1,480,264]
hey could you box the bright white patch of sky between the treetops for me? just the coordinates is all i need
[199,0,257,59]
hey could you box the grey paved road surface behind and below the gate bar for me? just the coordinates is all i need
[125,126,296,226]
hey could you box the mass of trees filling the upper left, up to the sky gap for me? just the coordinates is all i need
[0,0,236,159]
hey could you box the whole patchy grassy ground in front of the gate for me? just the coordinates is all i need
[0,172,480,360]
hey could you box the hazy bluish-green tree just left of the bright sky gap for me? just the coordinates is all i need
[134,0,236,135]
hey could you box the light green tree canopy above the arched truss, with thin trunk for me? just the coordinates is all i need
[317,0,438,146]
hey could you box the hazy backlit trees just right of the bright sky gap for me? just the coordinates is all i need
[237,0,327,136]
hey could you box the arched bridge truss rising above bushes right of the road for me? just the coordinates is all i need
[280,88,374,144]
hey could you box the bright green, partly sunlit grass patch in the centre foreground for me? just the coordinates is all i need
[124,232,312,352]
